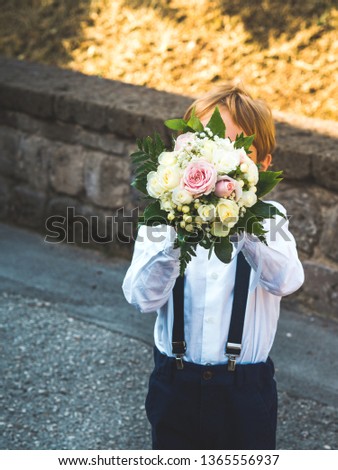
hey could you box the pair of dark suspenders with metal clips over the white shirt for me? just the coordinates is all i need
[172,251,251,371]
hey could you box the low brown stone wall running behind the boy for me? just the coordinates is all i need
[0,57,338,319]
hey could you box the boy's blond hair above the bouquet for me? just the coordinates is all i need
[184,82,276,162]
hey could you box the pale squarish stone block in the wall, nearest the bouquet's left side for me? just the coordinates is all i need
[85,152,130,209]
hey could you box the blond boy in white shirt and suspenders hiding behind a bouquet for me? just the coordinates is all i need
[122,84,304,449]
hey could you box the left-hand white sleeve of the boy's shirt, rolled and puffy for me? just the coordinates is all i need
[122,224,180,313]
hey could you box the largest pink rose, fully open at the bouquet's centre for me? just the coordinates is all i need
[182,159,217,197]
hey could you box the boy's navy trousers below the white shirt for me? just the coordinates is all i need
[145,346,277,450]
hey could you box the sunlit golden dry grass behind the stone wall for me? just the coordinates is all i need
[0,0,338,119]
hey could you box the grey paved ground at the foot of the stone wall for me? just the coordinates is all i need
[0,224,338,449]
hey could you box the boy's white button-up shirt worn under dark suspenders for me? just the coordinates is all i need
[122,201,304,364]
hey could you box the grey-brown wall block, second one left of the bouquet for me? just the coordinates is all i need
[46,142,85,196]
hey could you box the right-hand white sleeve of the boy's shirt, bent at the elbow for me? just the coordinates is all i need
[242,201,304,297]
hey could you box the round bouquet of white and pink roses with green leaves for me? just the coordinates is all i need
[130,107,284,276]
